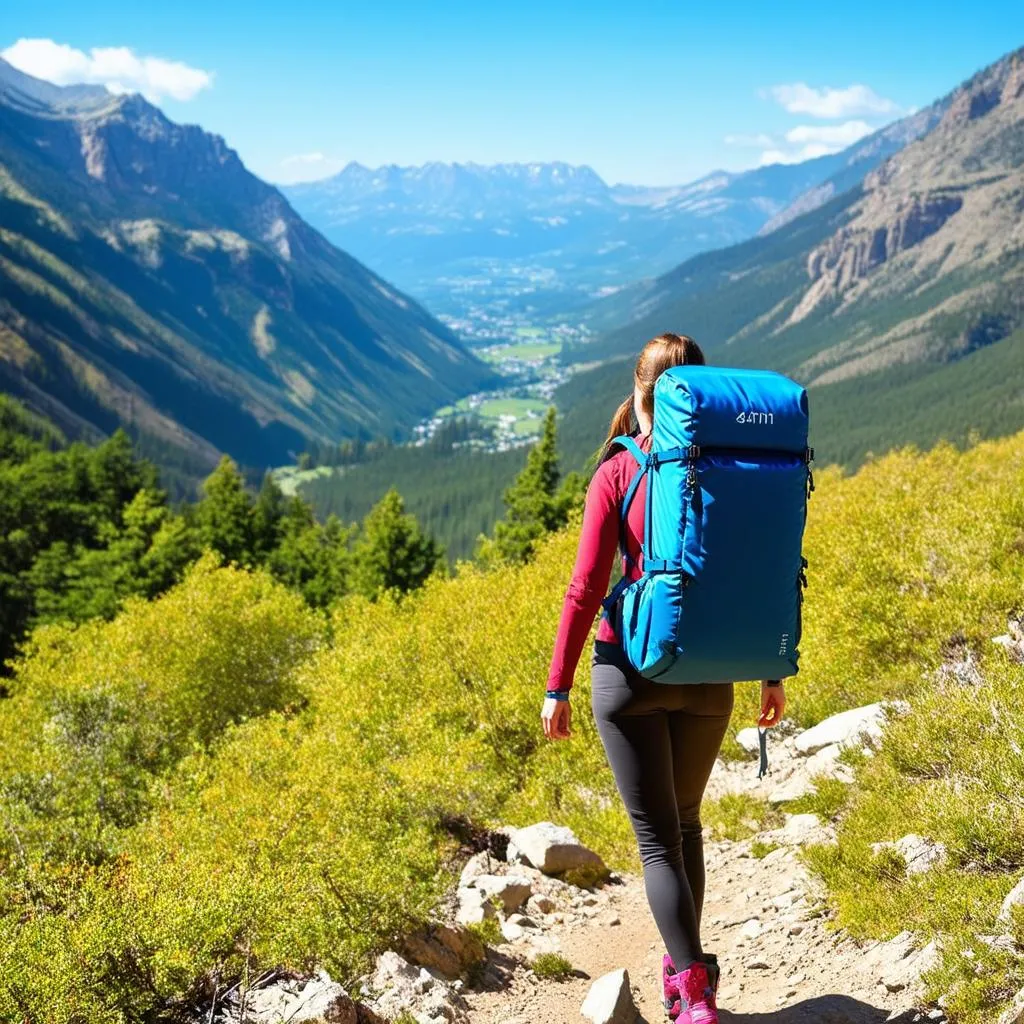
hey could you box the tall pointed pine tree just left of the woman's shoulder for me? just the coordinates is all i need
[477,407,586,563]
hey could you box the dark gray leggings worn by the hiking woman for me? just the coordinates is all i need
[591,640,732,971]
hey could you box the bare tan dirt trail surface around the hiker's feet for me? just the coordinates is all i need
[464,831,943,1024]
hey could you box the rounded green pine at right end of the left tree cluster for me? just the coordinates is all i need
[351,488,444,599]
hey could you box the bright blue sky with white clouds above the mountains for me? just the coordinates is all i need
[0,0,1024,184]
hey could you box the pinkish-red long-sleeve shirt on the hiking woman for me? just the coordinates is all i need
[548,435,650,691]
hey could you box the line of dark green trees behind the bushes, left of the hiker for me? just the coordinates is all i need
[0,396,583,665]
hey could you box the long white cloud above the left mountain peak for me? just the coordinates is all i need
[0,39,213,103]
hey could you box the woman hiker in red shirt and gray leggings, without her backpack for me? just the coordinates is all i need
[541,334,785,1024]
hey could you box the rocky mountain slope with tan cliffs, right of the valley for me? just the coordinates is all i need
[559,49,1024,462]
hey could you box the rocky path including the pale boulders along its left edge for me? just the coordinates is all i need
[211,705,946,1024]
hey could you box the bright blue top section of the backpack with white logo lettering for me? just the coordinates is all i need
[652,367,808,455]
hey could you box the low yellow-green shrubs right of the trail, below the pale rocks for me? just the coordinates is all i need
[808,652,1024,1024]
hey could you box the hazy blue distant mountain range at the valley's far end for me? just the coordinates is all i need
[283,104,943,311]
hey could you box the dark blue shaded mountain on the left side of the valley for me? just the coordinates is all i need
[0,60,492,472]
